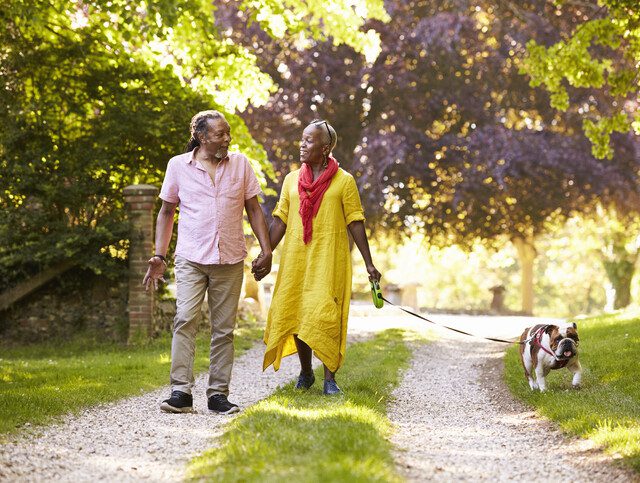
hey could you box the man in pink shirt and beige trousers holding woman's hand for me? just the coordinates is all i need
[143,111,271,414]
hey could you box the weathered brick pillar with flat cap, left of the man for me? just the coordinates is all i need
[124,184,158,343]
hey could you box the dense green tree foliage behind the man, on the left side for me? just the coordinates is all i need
[0,2,266,287]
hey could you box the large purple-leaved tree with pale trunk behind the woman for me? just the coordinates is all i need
[239,0,637,312]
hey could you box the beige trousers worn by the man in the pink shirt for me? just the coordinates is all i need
[171,257,244,397]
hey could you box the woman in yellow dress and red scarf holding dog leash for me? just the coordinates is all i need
[253,121,380,394]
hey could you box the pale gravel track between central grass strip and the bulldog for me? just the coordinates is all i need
[389,335,640,482]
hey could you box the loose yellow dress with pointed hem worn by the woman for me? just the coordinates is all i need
[263,169,364,372]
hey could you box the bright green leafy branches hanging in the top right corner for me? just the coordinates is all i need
[521,0,640,159]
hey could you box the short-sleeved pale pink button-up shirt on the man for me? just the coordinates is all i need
[160,151,260,265]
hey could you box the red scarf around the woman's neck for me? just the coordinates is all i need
[298,156,338,244]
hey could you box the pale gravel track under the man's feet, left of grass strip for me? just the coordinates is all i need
[0,343,308,482]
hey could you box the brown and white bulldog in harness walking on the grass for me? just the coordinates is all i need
[520,324,582,391]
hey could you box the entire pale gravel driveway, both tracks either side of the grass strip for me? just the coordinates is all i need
[0,308,640,482]
